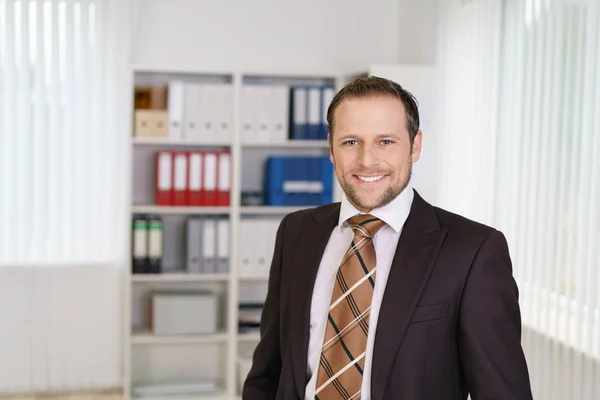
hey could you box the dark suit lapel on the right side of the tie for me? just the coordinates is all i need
[371,191,447,400]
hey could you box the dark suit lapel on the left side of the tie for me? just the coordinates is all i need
[289,203,340,399]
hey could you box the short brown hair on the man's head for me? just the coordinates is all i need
[327,76,419,144]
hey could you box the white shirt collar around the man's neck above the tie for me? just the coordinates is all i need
[338,182,414,233]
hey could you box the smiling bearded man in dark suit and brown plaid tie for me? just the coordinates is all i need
[242,77,532,400]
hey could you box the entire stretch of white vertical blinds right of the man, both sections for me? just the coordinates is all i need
[439,0,600,400]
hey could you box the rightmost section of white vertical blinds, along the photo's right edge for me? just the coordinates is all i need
[494,0,600,400]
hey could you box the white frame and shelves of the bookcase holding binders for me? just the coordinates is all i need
[123,66,356,400]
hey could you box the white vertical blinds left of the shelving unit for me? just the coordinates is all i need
[0,0,136,266]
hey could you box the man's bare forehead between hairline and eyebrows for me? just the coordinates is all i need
[334,95,407,131]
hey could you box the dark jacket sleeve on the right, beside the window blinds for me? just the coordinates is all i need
[458,230,532,400]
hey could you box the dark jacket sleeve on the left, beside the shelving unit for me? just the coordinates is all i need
[242,216,289,400]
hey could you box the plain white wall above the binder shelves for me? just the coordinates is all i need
[132,0,438,70]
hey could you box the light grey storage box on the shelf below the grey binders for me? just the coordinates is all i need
[150,293,218,335]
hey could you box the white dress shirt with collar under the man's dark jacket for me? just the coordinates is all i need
[305,183,414,400]
